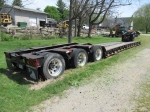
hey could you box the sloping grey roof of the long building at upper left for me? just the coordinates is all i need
[3,5,47,15]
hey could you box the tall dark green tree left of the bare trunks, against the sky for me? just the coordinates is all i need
[56,0,69,20]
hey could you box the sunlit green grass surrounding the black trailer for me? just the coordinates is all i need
[0,36,150,112]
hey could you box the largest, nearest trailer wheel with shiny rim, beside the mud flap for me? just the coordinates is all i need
[42,53,65,79]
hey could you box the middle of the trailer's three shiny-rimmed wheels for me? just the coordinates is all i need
[71,49,88,68]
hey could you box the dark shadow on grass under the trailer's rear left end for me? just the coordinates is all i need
[0,68,36,85]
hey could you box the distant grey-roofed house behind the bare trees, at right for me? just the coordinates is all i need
[100,17,133,29]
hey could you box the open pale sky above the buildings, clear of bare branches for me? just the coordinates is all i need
[9,0,150,17]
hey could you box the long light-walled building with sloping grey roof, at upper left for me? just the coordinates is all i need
[0,6,47,27]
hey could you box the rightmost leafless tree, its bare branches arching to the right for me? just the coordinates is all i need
[88,0,131,37]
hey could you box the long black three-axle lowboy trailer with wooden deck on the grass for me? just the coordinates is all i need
[4,42,140,81]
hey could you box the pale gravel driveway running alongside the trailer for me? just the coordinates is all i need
[32,49,150,112]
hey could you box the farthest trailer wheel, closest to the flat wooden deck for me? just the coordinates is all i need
[90,46,103,62]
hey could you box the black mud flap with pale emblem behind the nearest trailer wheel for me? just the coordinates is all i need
[27,66,39,81]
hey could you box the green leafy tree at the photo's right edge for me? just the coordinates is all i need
[133,3,150,33]
